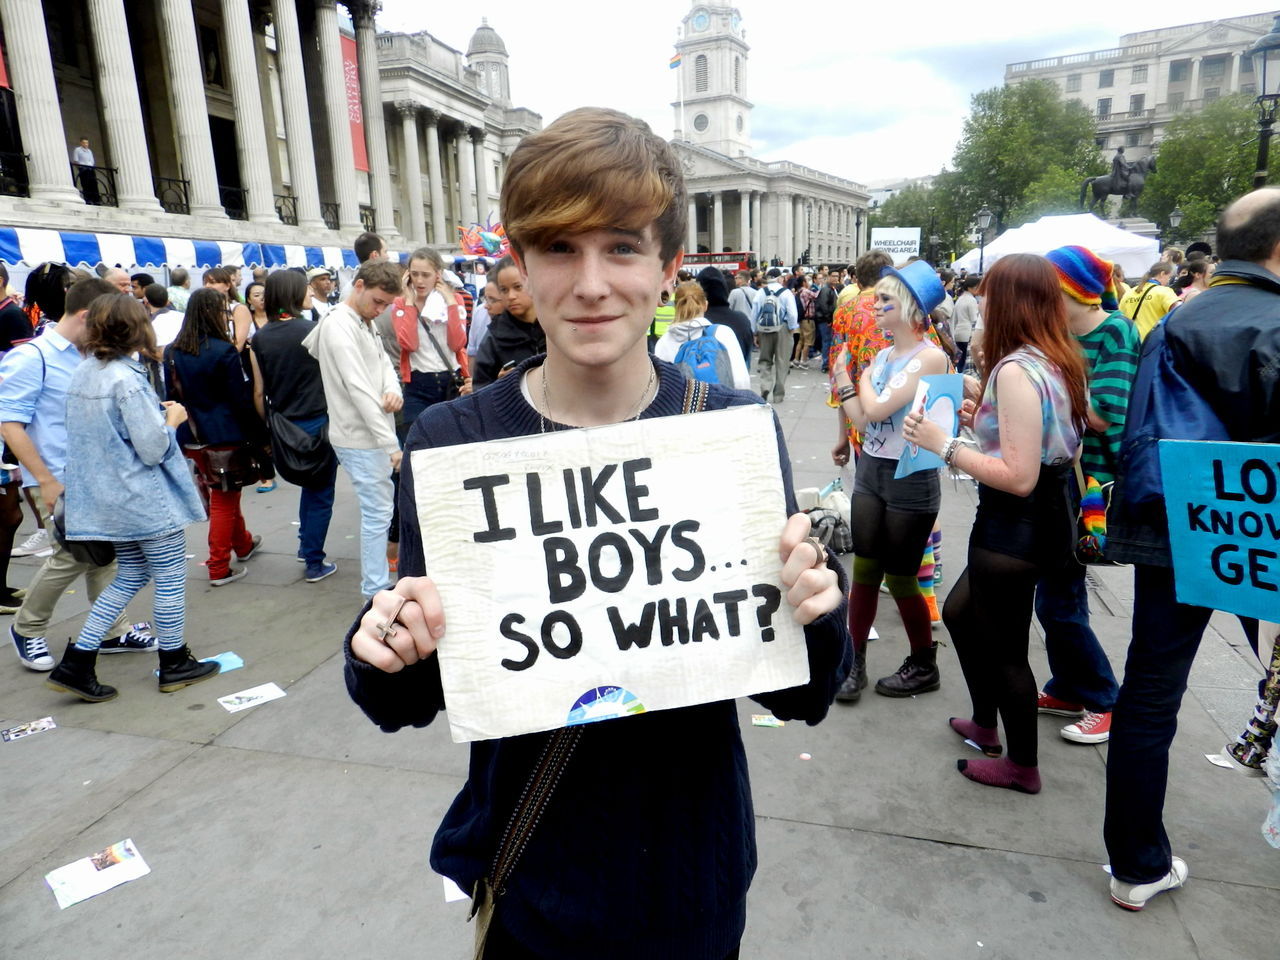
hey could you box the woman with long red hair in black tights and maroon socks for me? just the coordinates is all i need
[905,253,1088,794]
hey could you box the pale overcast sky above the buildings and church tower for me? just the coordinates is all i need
[379,0,1267,183]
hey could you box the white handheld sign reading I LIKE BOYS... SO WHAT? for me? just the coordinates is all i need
[411,404,809,742]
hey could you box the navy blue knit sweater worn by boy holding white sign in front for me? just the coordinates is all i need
[346,357,850,960]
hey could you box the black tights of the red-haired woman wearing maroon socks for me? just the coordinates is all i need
[942,544,1041,767]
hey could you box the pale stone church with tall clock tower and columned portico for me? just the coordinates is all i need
[672,0,869,265]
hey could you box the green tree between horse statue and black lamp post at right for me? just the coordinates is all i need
[1138,95,1259,239]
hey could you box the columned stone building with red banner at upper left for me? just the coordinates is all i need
[0,0,541,248]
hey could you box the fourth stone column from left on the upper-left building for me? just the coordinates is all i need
[221,0,280,223]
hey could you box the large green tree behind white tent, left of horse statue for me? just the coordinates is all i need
[952,79,1105,232]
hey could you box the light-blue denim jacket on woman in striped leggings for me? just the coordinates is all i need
[65,357,205,540]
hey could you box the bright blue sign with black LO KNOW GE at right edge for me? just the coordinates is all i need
[1160,440,1280,621]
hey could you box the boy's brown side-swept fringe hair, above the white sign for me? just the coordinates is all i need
[502,106,689,264]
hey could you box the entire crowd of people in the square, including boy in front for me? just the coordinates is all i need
[0,109,1280,959]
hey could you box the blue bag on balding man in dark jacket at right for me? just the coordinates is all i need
[1116,323,1231,503]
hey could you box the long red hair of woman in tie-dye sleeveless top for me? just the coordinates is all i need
[978,253,1089,430]
